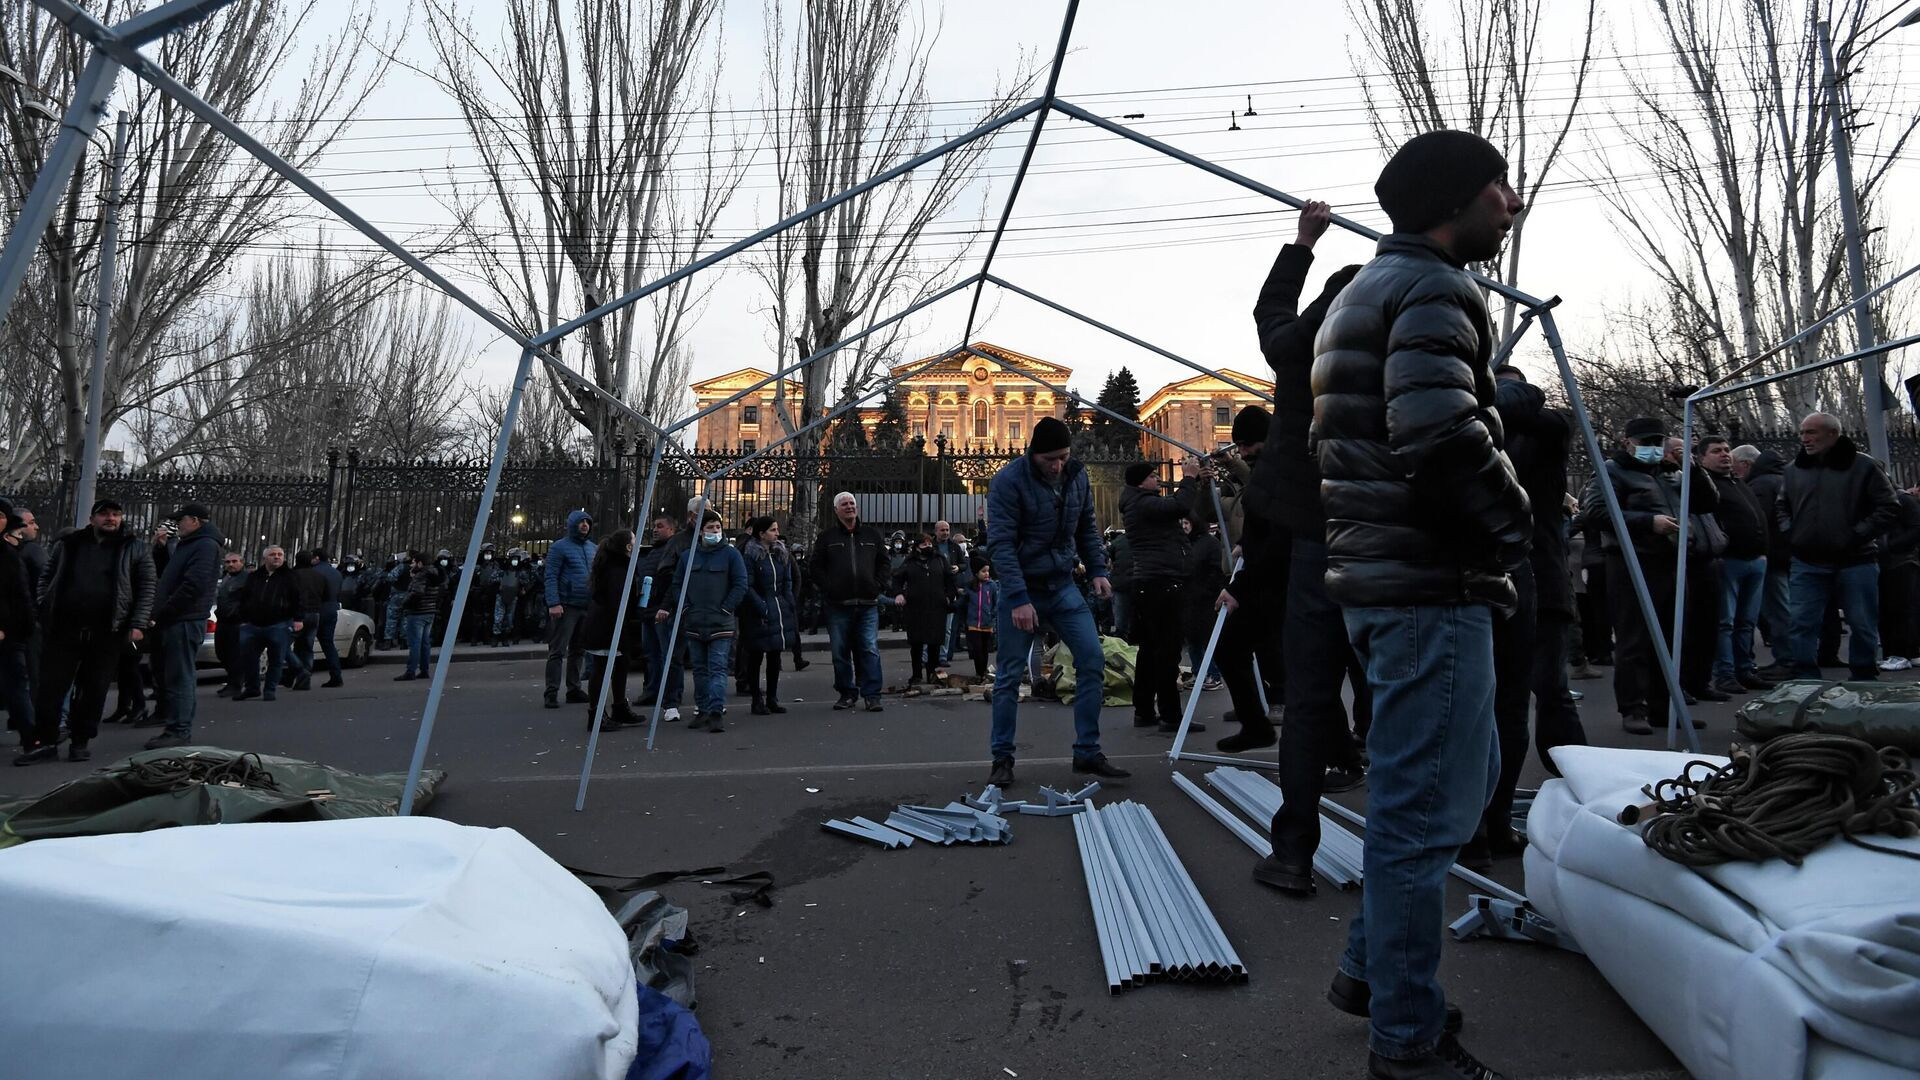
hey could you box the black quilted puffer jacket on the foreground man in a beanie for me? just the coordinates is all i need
[1311,233,1534,607]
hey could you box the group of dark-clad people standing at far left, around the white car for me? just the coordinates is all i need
[0,498,389,765]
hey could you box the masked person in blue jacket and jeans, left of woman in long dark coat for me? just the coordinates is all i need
[653,509,766,734]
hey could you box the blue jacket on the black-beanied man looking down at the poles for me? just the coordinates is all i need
[987,454,1108,607]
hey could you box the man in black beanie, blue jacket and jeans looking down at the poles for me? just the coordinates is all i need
[987,417,1129,790]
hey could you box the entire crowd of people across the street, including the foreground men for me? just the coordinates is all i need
[0,131,1920,1078]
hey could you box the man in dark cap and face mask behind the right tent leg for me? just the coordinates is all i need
[1580,417,1720,734]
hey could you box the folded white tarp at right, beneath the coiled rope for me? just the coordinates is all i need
[1526,746,1920,1080]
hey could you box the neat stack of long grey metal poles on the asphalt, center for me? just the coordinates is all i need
[1073,801,1246,994]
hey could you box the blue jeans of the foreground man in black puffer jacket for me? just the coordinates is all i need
[1340,605,1500,1059]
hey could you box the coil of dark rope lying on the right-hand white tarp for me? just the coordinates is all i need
[1644,732,1920,867]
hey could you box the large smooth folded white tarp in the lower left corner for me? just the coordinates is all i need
[0,817,637,1080]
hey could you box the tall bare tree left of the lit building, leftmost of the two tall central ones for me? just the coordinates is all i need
[426,0,743,459]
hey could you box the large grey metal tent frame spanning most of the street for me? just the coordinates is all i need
[0,0,1693,815]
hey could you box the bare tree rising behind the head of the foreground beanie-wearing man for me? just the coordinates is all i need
[1348,0,1599,334]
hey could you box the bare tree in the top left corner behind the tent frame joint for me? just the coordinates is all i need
[0,0,386,480]
